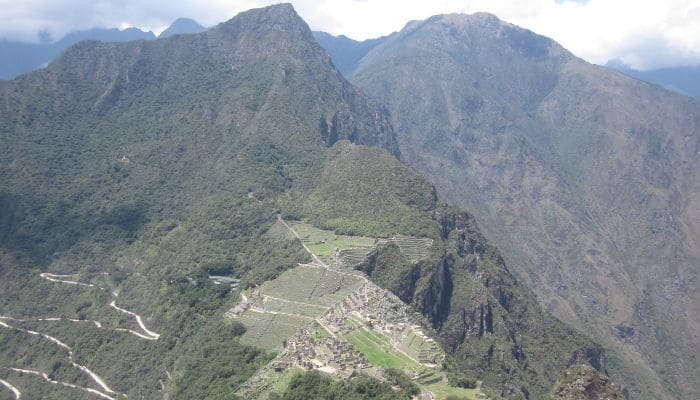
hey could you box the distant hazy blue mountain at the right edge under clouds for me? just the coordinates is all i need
[606,60,700,99]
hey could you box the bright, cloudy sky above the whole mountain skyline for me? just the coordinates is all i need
[0,0,700,70]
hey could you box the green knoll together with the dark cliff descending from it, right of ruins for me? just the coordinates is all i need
[294,143,606,399]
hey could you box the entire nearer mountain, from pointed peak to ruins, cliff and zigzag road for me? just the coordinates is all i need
[0,5,606,399]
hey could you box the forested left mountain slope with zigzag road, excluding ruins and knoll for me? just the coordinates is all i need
[0,6,396,399]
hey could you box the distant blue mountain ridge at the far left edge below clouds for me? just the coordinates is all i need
[0,28,155,79]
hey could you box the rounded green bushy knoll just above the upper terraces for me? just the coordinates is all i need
[283,142,437,237]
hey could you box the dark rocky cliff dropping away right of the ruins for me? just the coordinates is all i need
[360,209,606,399]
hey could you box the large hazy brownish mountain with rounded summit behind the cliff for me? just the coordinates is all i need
[350,14,700,399]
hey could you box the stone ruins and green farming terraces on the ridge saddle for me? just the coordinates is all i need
[228,218,476,398]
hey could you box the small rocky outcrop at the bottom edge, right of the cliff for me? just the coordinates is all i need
[550,364,625,400]
